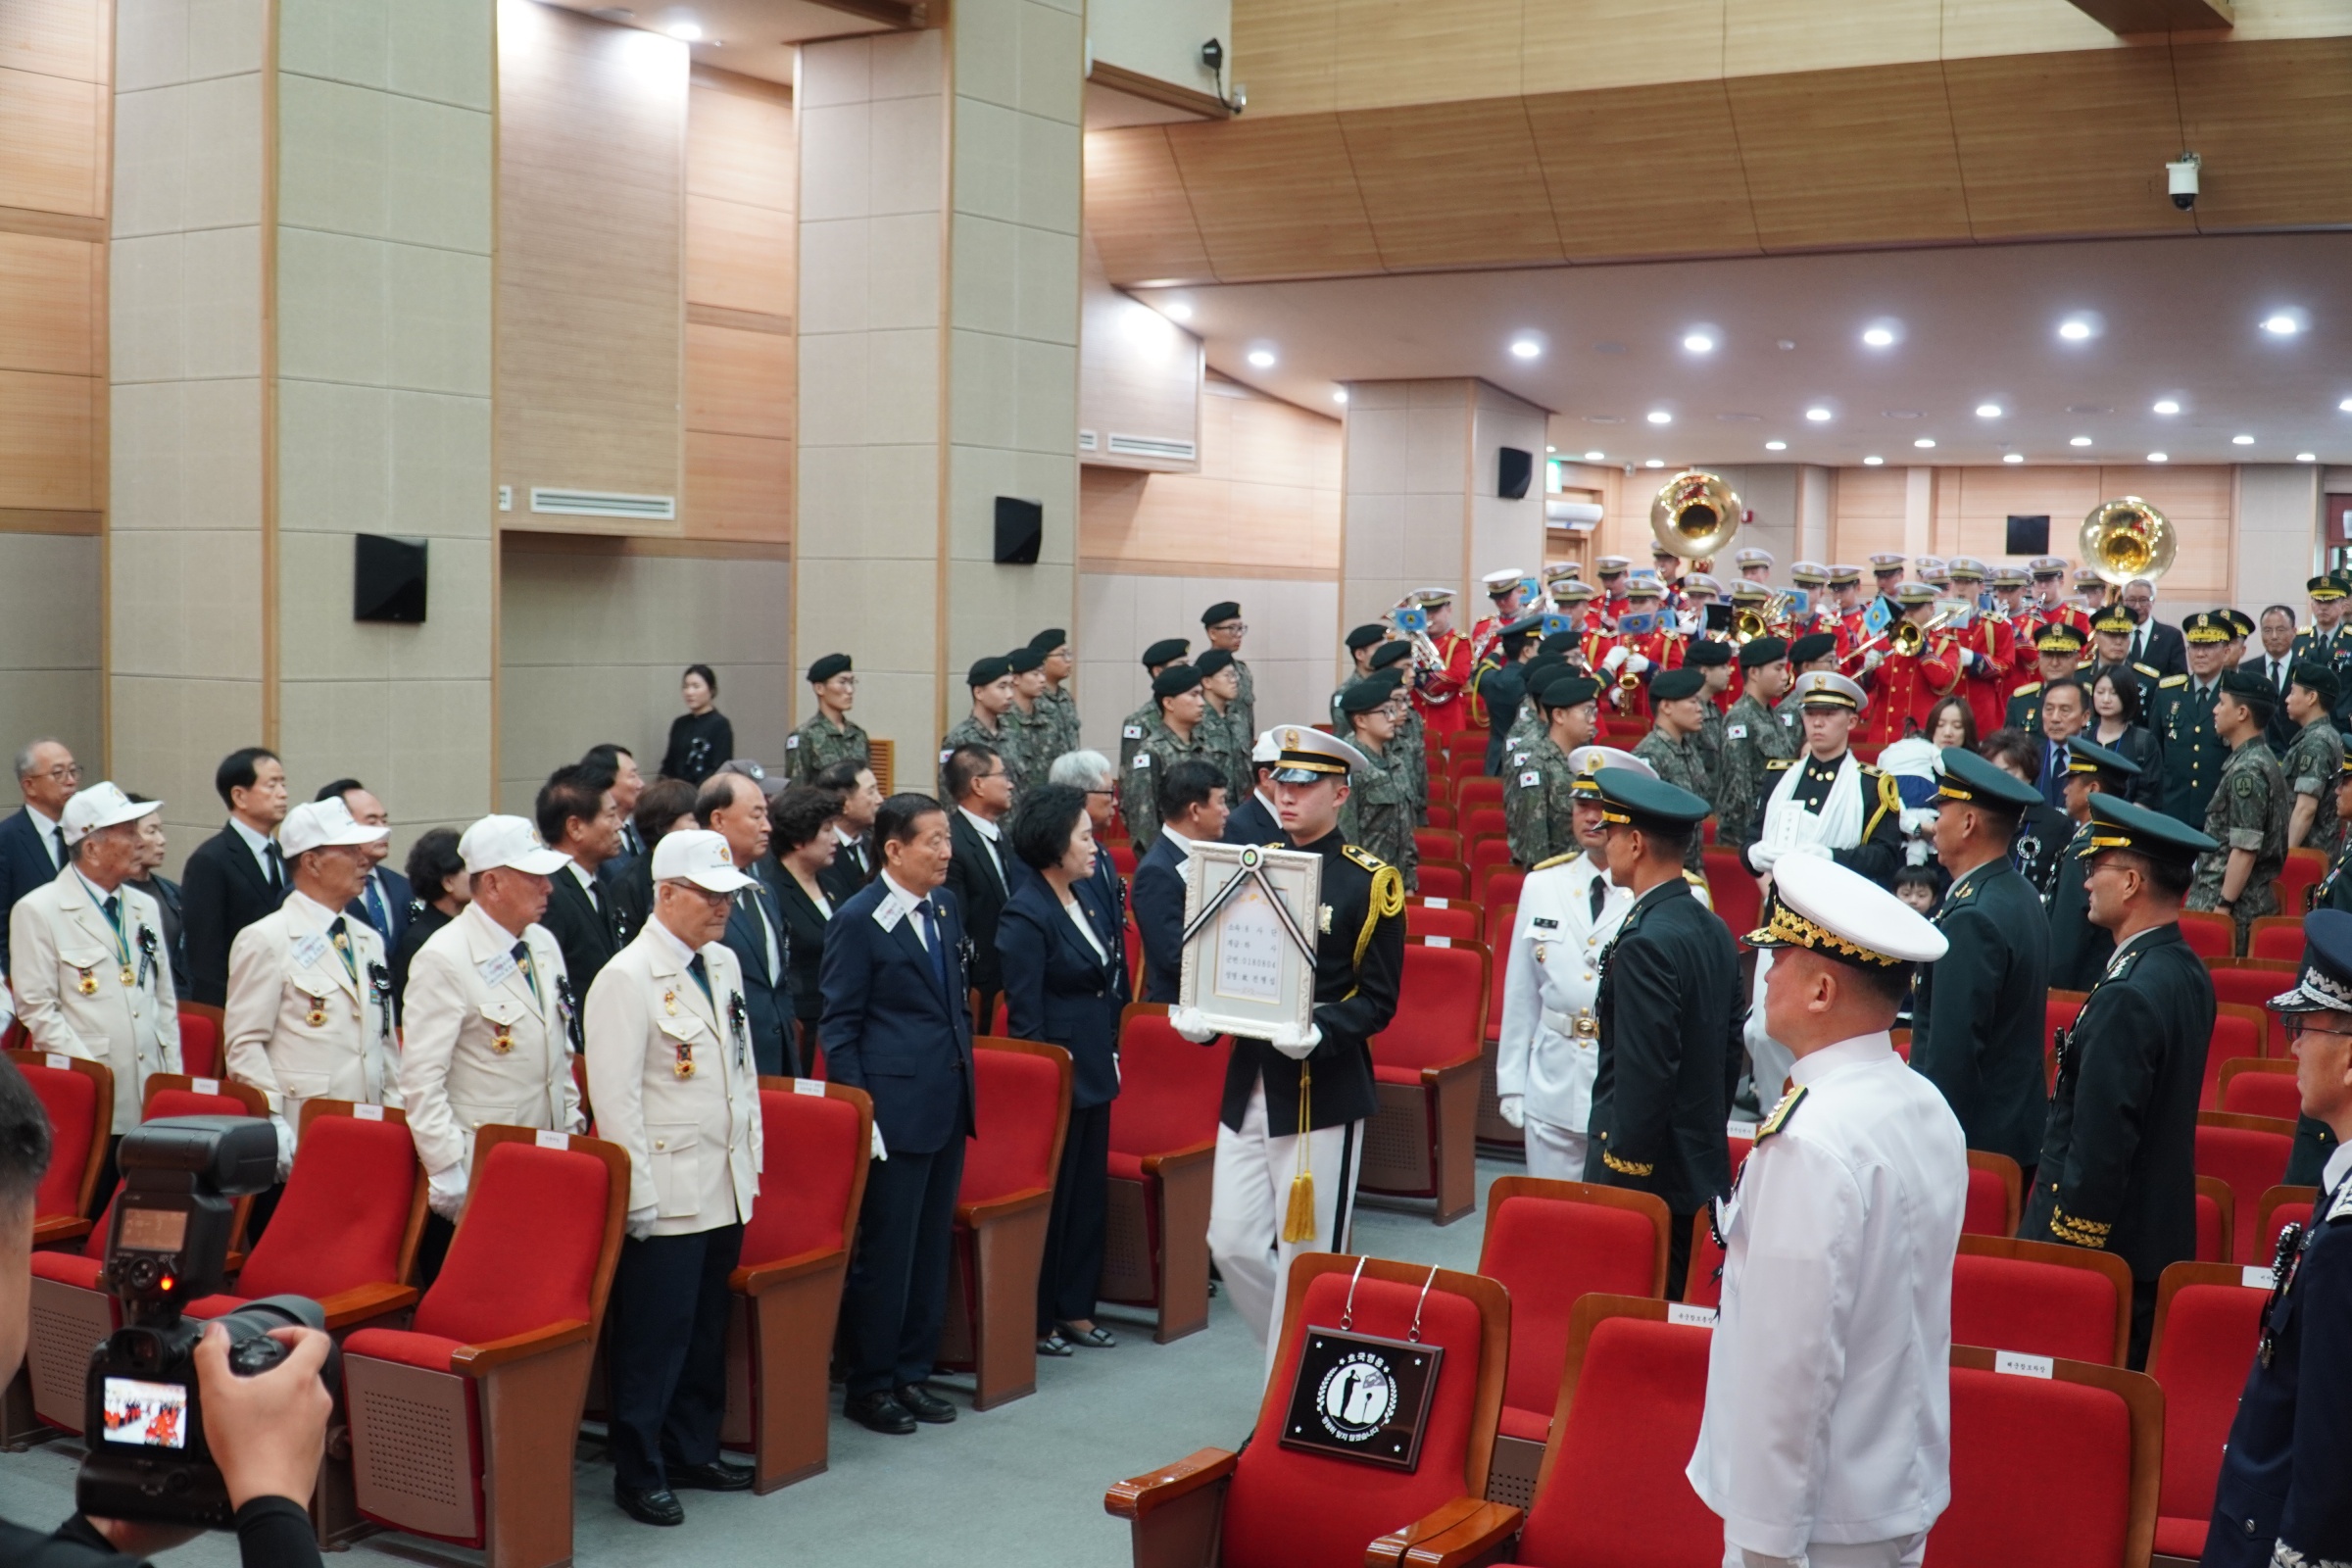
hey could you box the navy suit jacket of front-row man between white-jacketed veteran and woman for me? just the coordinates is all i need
[816,877,974,1154]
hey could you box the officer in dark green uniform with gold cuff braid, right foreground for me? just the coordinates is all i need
[2018,795,2218,1371]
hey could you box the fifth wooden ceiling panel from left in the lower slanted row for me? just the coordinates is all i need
[1724,61,1969,252]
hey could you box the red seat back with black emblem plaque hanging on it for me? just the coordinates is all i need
[1218,1272,1484,1568]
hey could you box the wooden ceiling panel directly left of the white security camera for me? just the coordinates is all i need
[1942,49,2197,240]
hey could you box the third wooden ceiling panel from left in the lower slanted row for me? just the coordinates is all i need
[1341,96,1566,270]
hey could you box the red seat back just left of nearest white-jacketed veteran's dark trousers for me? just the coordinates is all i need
[414,1143,612,1345]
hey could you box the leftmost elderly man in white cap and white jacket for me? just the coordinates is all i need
[0,783,178,1161]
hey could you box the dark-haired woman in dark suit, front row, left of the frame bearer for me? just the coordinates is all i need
[998,785,1127,1356]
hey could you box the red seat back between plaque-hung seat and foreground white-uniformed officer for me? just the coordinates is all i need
[1517,1316,1724,1568]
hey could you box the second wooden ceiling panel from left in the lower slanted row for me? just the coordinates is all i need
[1166,116,1381,279]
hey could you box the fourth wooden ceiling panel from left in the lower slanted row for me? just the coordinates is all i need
[1527,82,1757,261]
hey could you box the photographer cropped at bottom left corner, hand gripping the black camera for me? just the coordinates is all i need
[0,1062,331,1568]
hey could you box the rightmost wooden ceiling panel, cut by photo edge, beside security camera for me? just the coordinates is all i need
[2174,37,2352,232]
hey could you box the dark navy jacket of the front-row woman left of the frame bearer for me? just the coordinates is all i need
[998,877,1127,1109]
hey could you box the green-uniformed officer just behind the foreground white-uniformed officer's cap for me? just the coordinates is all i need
[1910,748,2048,1168]
